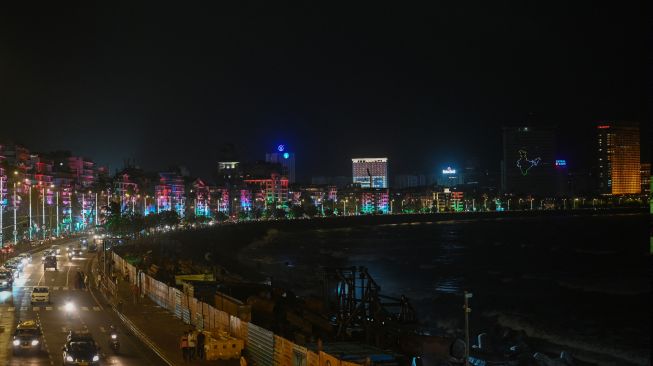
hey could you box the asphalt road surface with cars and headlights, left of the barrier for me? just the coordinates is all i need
[0,239,165,366]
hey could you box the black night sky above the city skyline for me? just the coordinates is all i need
[0,1,651,179]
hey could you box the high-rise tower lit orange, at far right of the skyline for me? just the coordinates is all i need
[596,122,642,194]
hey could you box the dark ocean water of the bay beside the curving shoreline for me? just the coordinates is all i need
[243,214,650,364]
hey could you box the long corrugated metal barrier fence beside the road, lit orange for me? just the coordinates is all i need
[113,253,366,366]
